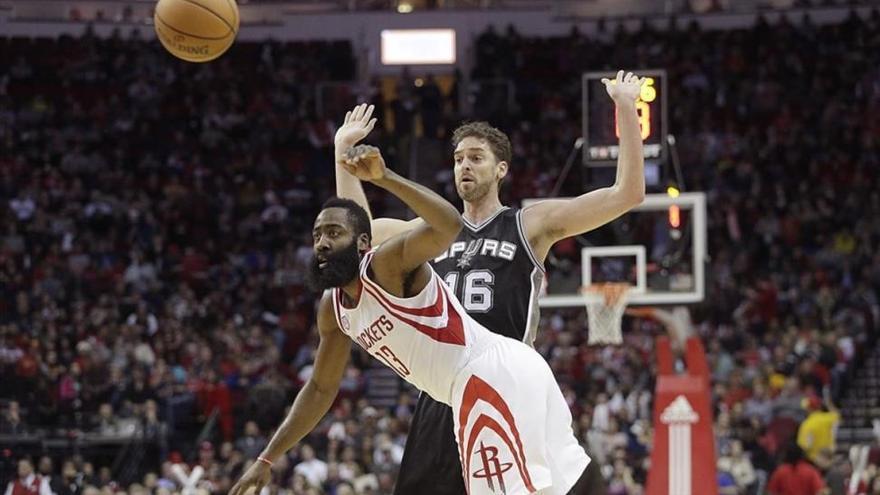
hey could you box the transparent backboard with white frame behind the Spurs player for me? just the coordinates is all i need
[522,192,707,307]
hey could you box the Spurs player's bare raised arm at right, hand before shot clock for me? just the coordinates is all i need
[523,71,645,260]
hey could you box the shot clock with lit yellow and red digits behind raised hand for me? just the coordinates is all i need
[582,70,667,166]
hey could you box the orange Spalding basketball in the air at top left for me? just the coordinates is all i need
[153,0,239,62]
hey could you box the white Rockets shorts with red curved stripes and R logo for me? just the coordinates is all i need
[452,338,590,495]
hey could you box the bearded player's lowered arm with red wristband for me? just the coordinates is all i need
[229,291,351,495]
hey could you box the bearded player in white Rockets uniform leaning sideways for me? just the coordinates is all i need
[230,145,590,495]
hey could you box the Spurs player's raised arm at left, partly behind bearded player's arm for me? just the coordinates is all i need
[333,103,424,246]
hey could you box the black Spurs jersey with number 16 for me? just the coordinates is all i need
[432,207,544,345]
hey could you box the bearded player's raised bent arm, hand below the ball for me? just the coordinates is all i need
[344,145,462,280]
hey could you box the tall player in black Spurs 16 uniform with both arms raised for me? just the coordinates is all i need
[335,71,645,495]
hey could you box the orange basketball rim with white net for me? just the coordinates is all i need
[581,283,632,345]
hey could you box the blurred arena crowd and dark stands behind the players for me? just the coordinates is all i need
[0,0,880,495]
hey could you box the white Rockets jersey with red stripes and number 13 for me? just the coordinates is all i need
[332,251,501,405]
